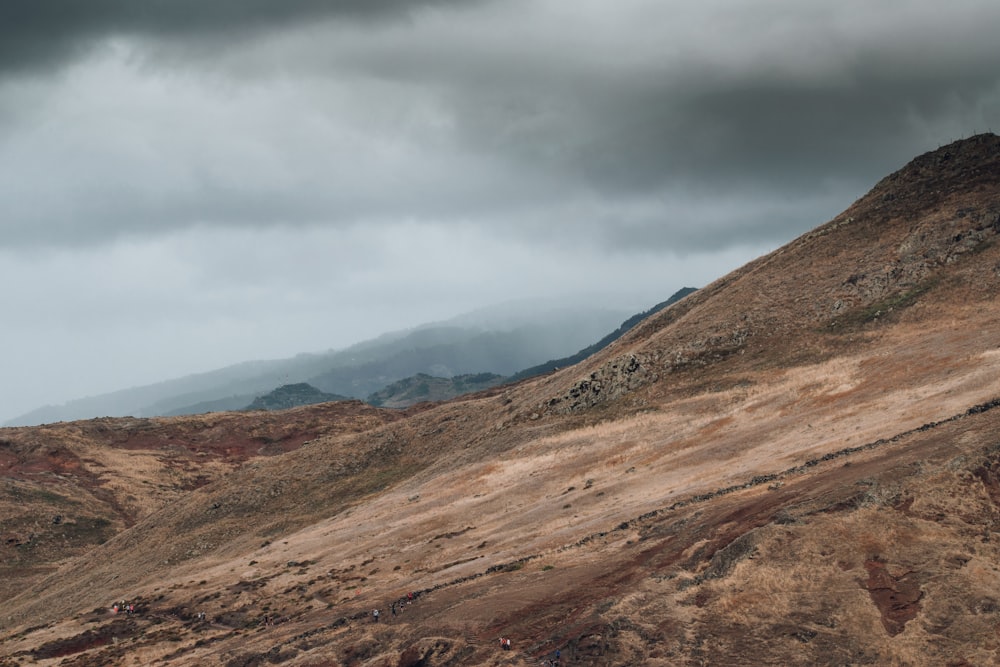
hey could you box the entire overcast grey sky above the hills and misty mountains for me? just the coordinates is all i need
[0,0,1000,422]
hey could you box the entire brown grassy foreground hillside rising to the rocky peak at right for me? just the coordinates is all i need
[0,135,1000,667]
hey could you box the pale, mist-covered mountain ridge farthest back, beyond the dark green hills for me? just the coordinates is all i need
[6,302,627,426]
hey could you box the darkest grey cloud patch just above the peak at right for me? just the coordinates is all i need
[480,22,1000,194]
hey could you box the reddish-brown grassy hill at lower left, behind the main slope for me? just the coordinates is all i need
[0,401,414,599]
